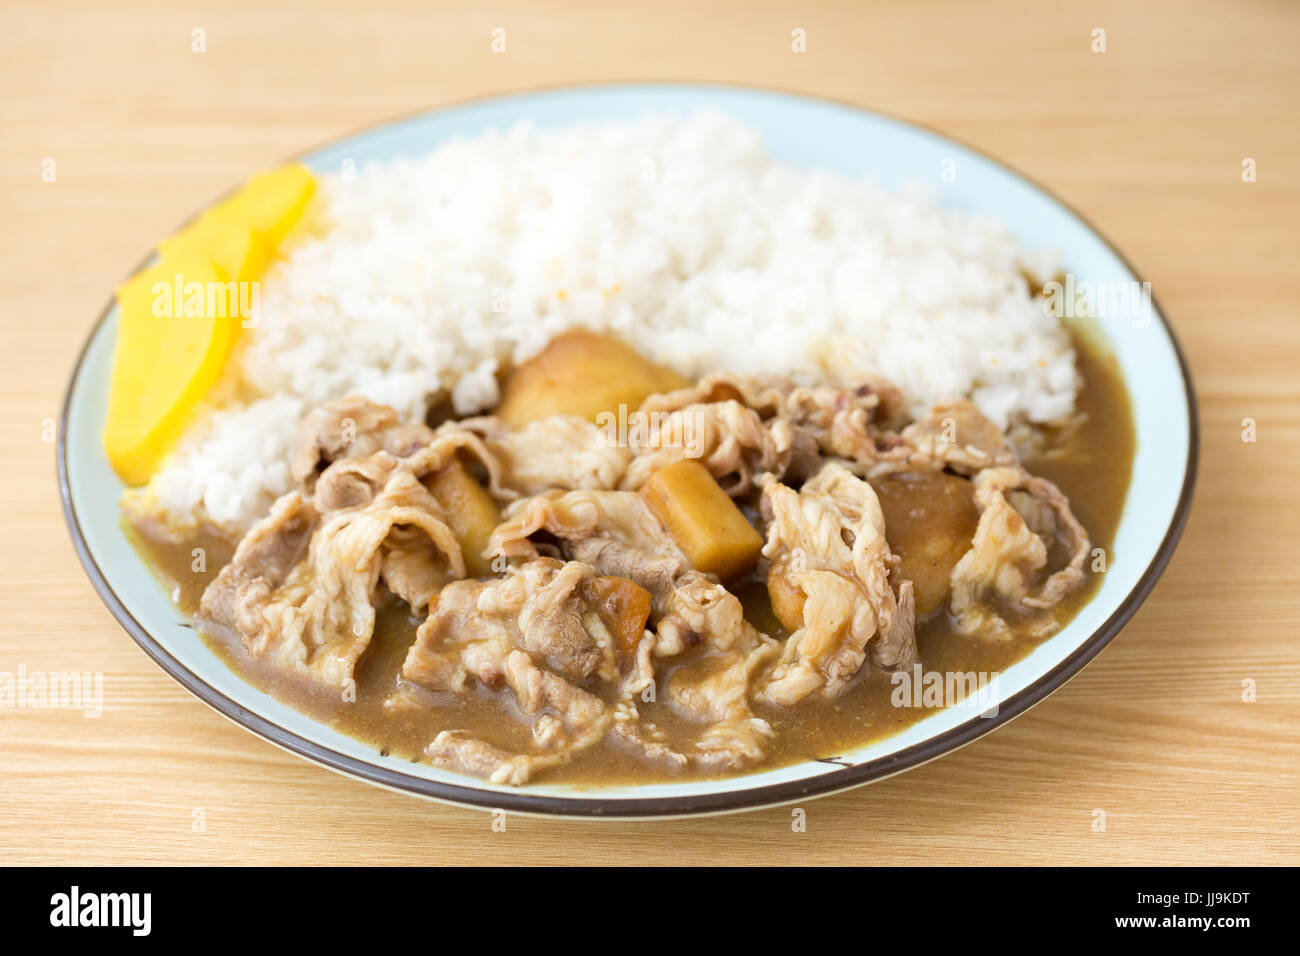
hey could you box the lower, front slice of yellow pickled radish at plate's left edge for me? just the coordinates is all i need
[104,254,241,484]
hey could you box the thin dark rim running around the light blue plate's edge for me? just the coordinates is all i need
[57,81,1200,819]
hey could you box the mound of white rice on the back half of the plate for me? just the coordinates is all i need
[146,113,1078,531]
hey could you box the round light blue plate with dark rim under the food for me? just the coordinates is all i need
[59,85,1197,817]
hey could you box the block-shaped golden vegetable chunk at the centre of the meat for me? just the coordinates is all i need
[641,458,763,581]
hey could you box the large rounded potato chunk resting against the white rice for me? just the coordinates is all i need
[497,330,689,428]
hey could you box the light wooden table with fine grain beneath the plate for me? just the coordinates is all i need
[0,0,1300,865]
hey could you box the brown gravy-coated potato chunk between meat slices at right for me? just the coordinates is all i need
[871,471,979,617]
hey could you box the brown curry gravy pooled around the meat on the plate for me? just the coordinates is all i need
[131,336,1136,784]
